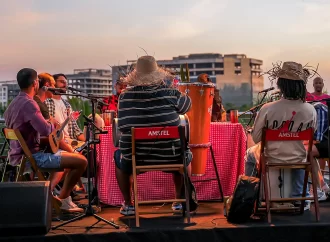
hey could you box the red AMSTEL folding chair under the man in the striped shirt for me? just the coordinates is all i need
[132,125,190,227]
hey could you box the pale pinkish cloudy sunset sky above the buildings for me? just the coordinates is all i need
[0,0,330,91]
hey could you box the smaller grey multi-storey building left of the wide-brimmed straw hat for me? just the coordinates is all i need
[66,68,112,96]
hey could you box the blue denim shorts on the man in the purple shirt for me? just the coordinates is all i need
[32,150,62,169]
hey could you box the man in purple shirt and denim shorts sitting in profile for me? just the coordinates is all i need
[4,68,87,212]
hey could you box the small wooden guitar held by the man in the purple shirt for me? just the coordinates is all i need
[41,111,82,154]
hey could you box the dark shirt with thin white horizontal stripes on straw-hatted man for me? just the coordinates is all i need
[118,85,191,164]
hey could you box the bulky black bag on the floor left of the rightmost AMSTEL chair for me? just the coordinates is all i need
[227,175,260,223]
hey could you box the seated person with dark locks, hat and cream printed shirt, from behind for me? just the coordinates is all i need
[245,62,317,209]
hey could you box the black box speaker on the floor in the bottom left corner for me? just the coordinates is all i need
[0,181,52,236]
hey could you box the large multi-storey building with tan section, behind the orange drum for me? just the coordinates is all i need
[112,53,264,107]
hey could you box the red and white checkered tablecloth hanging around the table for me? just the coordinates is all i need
[98,123,246,206]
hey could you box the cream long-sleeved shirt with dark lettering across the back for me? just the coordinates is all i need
[252,98,317,163]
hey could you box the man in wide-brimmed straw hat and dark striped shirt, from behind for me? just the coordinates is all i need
[116,56,191,215]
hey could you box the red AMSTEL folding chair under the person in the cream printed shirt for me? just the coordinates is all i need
[260,128,320,223]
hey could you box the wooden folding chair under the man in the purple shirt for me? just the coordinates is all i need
[2,128,63,215]
